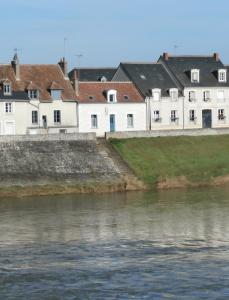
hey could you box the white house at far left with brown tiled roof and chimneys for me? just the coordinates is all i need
[0,55,78,135]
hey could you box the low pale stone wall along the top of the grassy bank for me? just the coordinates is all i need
[106,128,229,139]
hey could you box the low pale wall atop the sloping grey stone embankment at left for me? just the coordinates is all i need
[0,133,96,143]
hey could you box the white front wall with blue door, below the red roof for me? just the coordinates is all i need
[78,103,146,137]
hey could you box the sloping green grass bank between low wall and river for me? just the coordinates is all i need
[110,135,229,185]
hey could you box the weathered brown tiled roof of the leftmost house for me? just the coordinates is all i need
[0,64,76,102]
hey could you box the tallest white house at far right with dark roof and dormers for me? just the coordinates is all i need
[159,53,229,129]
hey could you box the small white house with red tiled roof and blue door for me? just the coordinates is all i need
[74,81,146,136]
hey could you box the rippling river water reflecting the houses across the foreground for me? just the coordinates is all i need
[0,188,229,300]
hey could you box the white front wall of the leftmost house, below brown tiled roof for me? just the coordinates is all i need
[0,99,78,135]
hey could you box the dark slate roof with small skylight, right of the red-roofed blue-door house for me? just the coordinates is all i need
[116,63,179,97]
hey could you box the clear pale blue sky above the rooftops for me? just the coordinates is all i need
[0,0,229,69]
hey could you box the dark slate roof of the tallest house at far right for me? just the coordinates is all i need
[159,55,229,87]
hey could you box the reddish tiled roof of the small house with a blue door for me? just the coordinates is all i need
[77,82,144,103]
